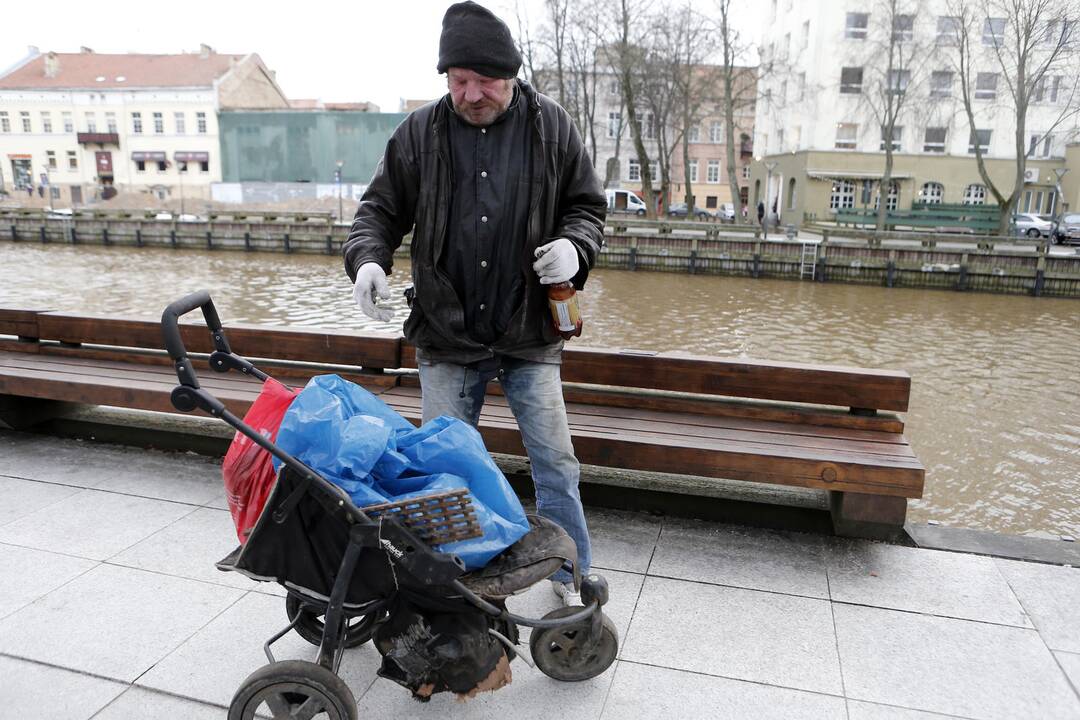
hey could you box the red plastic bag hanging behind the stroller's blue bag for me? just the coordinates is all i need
[221,378,296,544]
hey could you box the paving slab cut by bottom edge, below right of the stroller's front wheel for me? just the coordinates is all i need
[600,661,847,720]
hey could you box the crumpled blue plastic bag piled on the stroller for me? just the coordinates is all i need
[274,375,529,570]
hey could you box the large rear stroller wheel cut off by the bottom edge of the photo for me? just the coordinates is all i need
[229,660,357,720]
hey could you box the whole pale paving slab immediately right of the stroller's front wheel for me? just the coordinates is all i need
[620,576,842,695]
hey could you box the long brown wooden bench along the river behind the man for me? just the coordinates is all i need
[0,309,924,535]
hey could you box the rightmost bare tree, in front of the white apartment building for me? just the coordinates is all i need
[948,0,1080,234]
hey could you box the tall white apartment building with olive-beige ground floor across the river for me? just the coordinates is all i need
[751,0,1080,225]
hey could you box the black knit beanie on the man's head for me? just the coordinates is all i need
[437,2,522,78]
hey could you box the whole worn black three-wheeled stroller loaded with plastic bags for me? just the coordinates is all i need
[161,290,619,720]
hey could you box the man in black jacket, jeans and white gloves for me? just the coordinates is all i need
[345,2,607,604]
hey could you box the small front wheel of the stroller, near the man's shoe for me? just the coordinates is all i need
[529,608,619,682]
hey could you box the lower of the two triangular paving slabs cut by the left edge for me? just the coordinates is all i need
[0,544,97,617]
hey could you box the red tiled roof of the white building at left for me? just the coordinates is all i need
[0,53,244,90]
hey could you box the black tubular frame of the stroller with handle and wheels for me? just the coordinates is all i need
[161,290,618,720]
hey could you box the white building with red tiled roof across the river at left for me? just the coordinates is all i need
[0,45,288,204]
